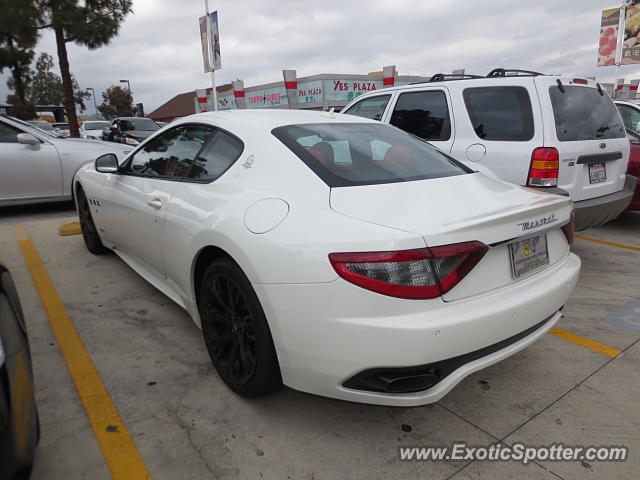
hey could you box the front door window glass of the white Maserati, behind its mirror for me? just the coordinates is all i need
[129,125,213,178]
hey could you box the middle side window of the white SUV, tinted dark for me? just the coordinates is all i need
[390,90,451,140]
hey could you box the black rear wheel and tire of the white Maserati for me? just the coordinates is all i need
[198,258,282,398]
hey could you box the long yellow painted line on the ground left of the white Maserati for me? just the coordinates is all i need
[15,225,151,480]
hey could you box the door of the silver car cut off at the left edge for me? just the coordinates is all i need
[0,120,63,202]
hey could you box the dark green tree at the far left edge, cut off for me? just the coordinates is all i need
[0,0,38,116]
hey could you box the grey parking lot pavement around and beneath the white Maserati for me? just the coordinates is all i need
[0,206,640,480]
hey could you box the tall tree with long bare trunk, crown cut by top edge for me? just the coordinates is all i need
[37,0,132,137]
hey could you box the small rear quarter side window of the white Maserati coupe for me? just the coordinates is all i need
[185,131,244,181]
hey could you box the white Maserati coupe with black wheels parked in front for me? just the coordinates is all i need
[74,110,580,406]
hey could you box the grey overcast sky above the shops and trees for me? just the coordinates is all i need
[0,0,640,113]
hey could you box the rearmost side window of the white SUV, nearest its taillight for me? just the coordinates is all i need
[462,87,533,142]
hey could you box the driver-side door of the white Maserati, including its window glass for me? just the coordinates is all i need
[101,124,213,278]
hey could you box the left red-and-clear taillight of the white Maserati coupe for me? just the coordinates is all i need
[329,242,489,299]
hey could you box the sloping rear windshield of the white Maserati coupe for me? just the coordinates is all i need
[272,123,472,187]
